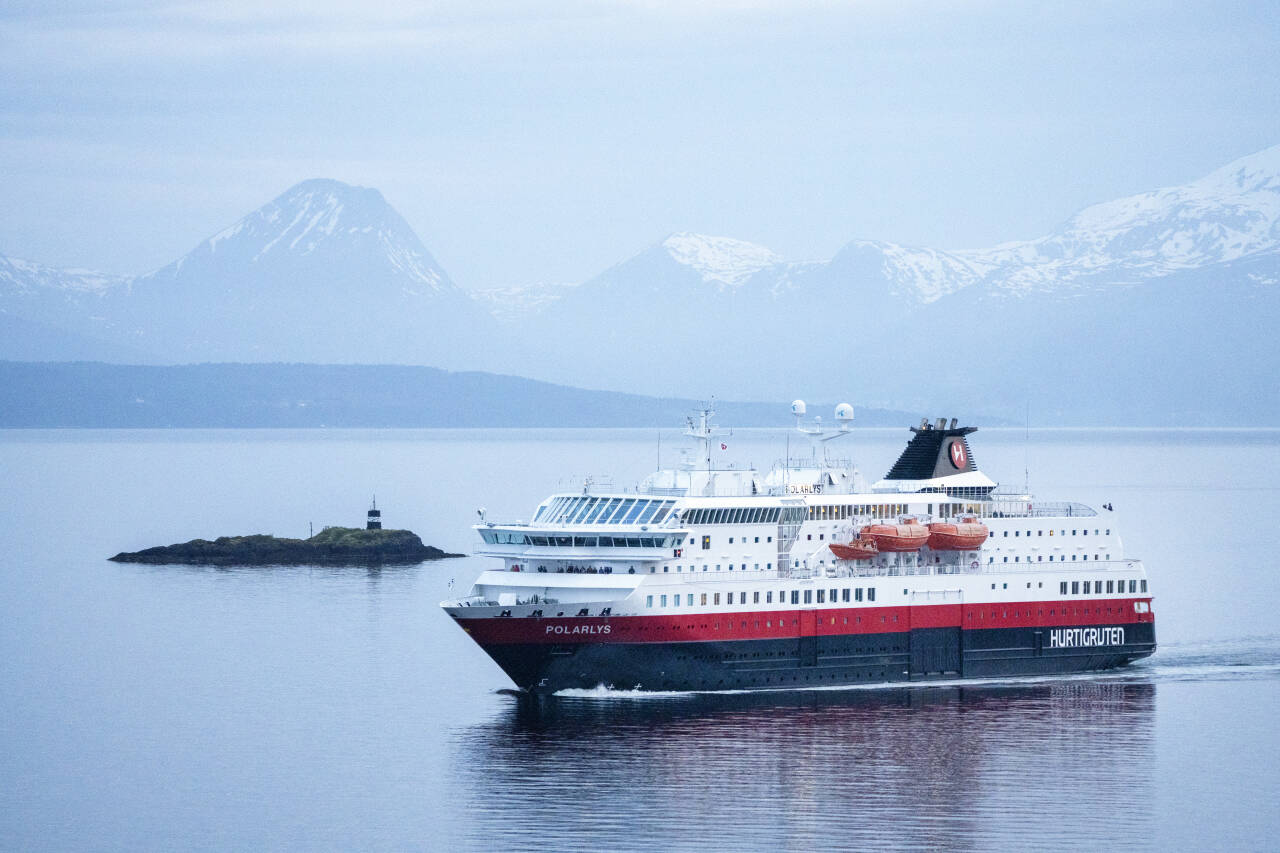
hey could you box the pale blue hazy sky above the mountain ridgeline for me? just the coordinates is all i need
[0,0,1280,287]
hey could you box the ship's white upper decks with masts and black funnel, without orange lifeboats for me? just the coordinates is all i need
[476,412,1124,578]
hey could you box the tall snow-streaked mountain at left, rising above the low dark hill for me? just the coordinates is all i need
[0,179,493,366]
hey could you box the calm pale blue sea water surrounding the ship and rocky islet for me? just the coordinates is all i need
[0,430,1280,850]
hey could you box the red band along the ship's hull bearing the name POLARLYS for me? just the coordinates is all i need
[458,598,1156,644]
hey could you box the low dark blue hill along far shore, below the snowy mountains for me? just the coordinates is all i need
[0,361,926,430]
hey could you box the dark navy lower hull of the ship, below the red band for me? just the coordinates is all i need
[485,622,1156,693]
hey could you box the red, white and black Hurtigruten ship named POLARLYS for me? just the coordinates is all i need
[442,400,1156,693]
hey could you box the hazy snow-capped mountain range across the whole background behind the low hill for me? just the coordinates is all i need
[0,146,1280,424]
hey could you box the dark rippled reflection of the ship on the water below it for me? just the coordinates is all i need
[454,679,1156,850]
